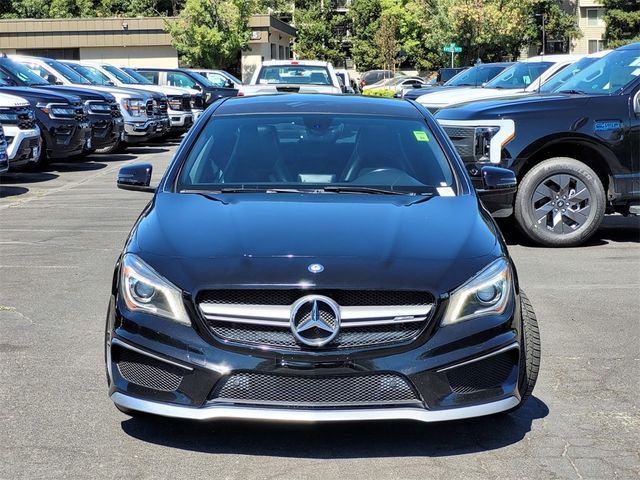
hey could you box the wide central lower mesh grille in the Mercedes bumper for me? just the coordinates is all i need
[213,373,419,407]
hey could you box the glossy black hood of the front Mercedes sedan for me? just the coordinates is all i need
[127,192,502,292]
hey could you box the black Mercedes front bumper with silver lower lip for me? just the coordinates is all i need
[105,297,521,422]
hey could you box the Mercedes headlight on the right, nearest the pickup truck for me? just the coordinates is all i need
[441,258,513,326]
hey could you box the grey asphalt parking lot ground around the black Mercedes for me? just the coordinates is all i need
[0,144,640,480]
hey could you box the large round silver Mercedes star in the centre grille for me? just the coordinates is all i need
[291,295,340,347]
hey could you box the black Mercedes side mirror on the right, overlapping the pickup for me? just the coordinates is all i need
[476,165,518,217]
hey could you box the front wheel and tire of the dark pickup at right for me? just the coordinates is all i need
[514,157,606,247]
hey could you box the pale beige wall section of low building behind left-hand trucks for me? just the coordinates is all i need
[80,46,178,68]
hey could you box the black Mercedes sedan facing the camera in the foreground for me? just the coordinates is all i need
[105,95,540,422]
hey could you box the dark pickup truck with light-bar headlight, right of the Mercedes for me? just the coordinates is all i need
[436,43,640,247]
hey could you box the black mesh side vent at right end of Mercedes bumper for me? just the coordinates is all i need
[447,349,518,394]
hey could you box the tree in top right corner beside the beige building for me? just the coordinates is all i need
[602,0,640,48]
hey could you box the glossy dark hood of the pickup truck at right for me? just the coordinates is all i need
[435,93,590,120]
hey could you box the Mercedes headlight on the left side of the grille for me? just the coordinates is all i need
[120,253,191,325]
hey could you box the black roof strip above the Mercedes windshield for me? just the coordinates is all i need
[214,93,423,119]
